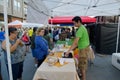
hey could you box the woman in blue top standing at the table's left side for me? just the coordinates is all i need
[34,28,48,67]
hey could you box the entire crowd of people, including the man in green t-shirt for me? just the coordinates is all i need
[0,16,94,80]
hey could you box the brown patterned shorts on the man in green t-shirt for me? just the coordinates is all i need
[78,46,90,70]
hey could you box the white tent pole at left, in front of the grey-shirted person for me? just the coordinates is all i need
[4,0,13,80]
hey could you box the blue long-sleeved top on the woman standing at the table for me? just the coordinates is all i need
[34,36,48,60]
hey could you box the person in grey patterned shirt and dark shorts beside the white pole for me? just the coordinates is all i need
[2,27,25,80]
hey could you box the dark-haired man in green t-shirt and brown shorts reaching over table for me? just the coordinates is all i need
[65,16,90,80]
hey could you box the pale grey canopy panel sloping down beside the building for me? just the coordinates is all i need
[25,0,49,25]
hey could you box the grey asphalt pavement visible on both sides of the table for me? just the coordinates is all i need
[1,45,120,80]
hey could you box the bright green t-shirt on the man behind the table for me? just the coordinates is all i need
[76,25,90,49]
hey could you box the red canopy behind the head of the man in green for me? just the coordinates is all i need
[49,16,96,24]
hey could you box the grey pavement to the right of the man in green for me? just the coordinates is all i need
[87,54,120,80]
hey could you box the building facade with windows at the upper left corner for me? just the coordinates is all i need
[0,0,25,22]
